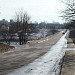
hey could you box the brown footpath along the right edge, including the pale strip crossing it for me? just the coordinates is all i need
[60,38,75,75]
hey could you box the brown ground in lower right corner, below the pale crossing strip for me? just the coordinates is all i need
[61,50,75,75]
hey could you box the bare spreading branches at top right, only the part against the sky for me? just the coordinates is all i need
[61,0,75,22]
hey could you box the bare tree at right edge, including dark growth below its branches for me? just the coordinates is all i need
[62,0,75,43]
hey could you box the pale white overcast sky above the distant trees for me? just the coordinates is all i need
[0,0,64,22]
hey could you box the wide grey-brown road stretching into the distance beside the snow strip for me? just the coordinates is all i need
[0,32,63,75]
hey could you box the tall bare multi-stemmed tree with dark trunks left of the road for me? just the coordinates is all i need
[15,9,30,45]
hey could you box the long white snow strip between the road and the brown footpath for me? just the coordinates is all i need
[6,33,67,75]
